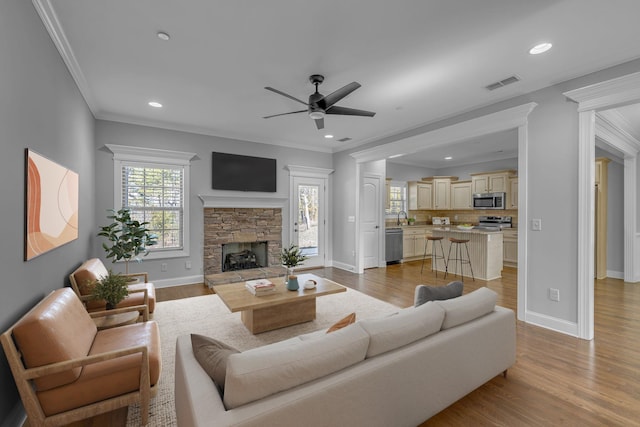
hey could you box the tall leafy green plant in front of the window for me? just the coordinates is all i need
[98,208,158,274]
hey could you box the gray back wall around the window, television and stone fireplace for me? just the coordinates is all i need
[93,120,332,283]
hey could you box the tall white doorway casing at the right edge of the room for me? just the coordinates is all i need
[563,72,640,340]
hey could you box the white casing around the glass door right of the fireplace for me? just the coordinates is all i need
[283,165,334,266]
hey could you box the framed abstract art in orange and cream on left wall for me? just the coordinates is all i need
[24,149,79,261]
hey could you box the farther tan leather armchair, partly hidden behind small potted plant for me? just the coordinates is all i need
[69,258,156,314]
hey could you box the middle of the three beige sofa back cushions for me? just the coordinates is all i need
[358,302,444,358]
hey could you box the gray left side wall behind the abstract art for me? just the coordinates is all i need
[0,0,96,425]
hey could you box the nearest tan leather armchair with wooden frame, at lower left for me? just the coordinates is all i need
[0,288,162,426]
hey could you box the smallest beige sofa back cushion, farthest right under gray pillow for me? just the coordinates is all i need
[435,287,498,329]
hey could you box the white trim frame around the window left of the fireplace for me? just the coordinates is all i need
[105,144,196,259]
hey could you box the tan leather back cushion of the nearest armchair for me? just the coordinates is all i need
[13,288,97,391]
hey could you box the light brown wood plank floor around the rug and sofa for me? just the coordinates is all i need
[57,261,640,427]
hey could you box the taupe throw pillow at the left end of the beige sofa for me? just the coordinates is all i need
[191,334,240,394]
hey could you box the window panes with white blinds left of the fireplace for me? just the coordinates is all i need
[121,162,185,252]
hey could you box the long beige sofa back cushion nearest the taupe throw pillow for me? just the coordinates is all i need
[224,323,369,409]
